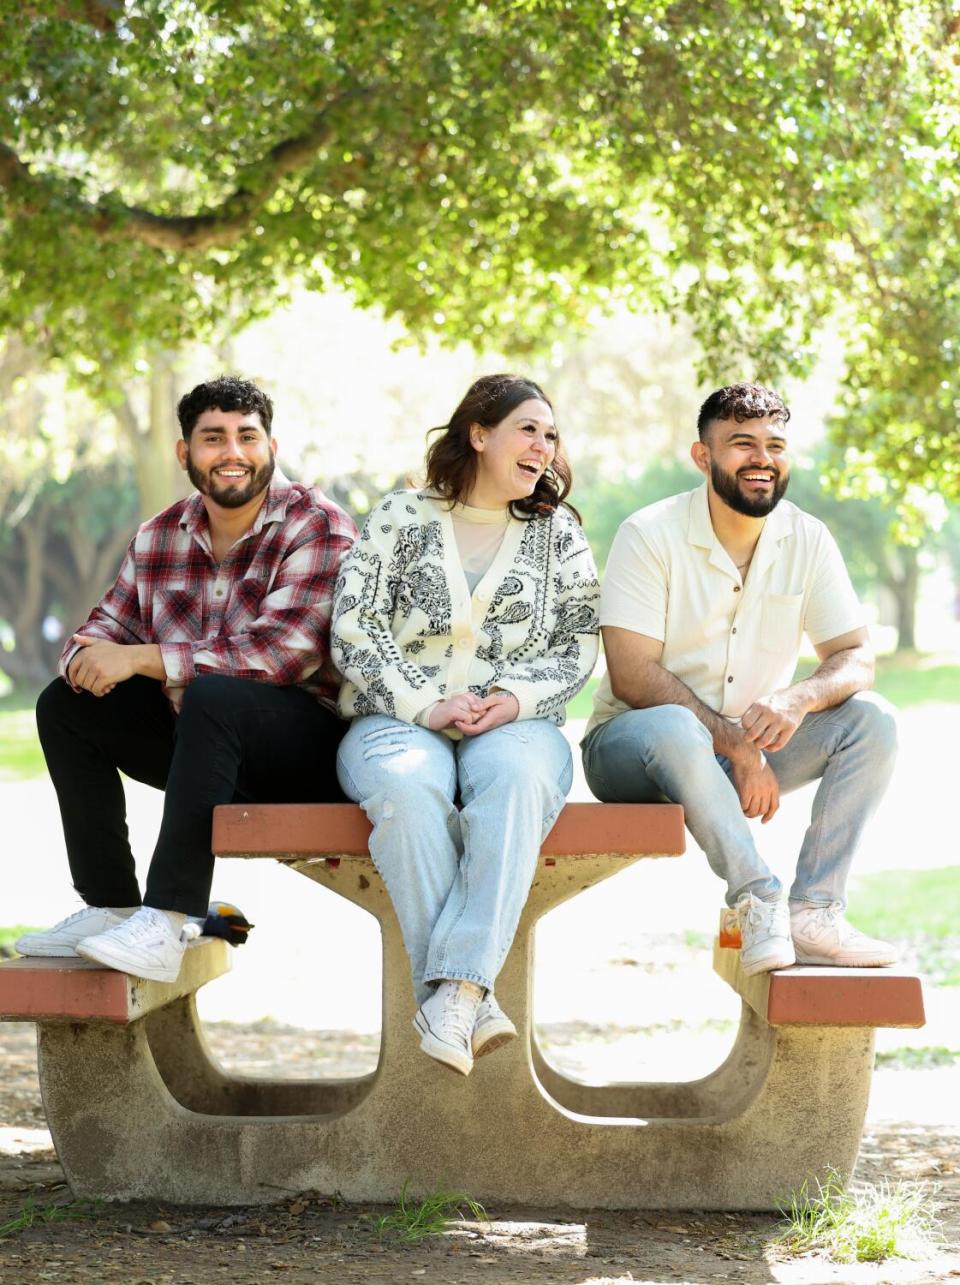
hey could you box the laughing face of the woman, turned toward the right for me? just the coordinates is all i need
[467,397,558,509]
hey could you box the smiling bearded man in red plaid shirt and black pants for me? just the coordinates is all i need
[17,378,356,982]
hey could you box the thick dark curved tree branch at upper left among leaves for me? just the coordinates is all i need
[0,86,373,251]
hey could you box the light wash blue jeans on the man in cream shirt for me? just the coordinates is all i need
[582,691,897,906]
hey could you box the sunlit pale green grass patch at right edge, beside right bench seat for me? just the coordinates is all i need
[851,866,960,986]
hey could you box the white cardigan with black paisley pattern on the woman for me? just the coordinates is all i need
[330,491,600,723]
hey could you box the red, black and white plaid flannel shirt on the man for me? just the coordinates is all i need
[60,473,356,709]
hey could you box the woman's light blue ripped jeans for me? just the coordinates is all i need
[337,714,573,1004]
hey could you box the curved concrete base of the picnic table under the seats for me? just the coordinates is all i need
[31,855,921,1209]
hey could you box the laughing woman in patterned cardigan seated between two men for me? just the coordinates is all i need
[332,375,599,1076]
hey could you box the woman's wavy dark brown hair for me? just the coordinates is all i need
[427,375,580,522]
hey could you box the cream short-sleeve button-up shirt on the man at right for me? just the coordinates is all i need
[587,483,864,734]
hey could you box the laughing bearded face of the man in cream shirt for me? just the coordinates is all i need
[691,415,790,518]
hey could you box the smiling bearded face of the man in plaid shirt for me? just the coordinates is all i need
[177,407,276,509]
